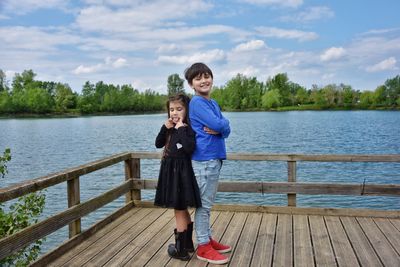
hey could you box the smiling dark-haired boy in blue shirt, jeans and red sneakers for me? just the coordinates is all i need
[185,63,231,264]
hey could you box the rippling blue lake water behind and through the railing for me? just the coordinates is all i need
[0,111,400,255]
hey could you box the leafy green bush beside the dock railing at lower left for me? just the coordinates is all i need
[0,149,45,266]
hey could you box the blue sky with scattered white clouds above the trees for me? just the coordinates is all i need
[0,0,400,93]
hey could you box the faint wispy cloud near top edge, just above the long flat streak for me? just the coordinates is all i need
[281,6,335,23]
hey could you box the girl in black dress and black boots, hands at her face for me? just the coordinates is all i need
[154,94,201,260]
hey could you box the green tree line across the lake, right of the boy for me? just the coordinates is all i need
[211,73,400,110]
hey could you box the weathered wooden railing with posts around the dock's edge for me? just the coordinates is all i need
[0,152,400,259]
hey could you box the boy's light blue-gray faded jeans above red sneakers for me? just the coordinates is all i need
[192,159,222,245]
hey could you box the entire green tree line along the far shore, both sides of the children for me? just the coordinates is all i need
[0,69,400,114]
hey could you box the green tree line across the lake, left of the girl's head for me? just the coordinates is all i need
[0,70,166,114]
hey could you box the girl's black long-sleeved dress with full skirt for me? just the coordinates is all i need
[154,125,201,210]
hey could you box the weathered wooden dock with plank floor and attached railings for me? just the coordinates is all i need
[0,152,400,267]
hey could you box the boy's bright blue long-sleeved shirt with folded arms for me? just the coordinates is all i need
[189,95,231,161]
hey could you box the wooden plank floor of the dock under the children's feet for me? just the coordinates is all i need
[46,208,400,267]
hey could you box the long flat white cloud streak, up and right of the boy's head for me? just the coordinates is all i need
[256,27,318,42]
